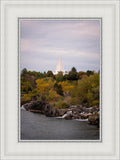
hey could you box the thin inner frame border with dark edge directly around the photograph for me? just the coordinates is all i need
[18,17,102,142]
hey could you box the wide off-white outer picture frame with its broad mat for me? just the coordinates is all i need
[1,0,120,160]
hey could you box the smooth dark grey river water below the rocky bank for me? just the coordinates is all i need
[20,109,99,140]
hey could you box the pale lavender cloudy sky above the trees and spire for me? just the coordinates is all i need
[19,19,100,72]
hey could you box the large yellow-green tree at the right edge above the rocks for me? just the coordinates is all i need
[71,73,99,106]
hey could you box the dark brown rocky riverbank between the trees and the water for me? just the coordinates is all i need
[22,101,99,127]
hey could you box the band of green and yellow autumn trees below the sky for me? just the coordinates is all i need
[21,67,99,108]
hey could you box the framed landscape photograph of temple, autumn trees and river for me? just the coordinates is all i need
[18,18,102,141]
